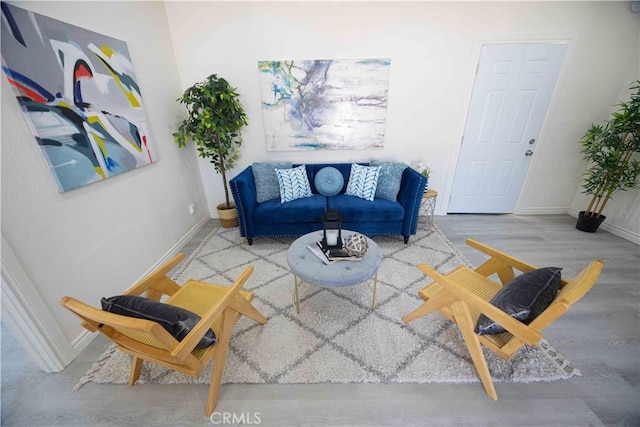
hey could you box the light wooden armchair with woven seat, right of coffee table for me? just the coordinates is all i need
[402,239,603,400]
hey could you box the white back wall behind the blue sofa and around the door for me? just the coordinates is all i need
[165,2,640,239]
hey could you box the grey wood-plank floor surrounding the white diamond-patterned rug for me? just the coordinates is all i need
[1,215,640,426]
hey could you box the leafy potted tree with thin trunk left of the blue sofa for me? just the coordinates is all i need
[173,74,247,227]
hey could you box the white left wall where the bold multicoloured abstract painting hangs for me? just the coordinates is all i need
[1,1,209,350]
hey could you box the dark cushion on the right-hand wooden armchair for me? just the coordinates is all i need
[476,267,562,335]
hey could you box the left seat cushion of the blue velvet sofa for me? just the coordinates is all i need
[253,194,327,224]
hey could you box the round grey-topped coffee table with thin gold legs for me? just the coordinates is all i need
[287,230,382,313]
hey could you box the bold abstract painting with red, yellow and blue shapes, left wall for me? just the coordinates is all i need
[2,2,157,192]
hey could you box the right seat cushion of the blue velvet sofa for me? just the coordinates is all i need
[327,194,404,223]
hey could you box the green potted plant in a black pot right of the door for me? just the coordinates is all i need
[576,80,640,233]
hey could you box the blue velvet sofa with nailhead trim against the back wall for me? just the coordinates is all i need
[229,163,427,245]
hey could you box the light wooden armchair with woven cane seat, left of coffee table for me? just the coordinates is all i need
[60,254,267,416]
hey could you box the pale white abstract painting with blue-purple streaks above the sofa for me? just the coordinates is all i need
[258,59,391,151]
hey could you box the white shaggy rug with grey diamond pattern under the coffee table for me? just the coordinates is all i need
[74,224,580,389]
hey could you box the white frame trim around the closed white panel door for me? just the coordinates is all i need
[438,37,575,215]
